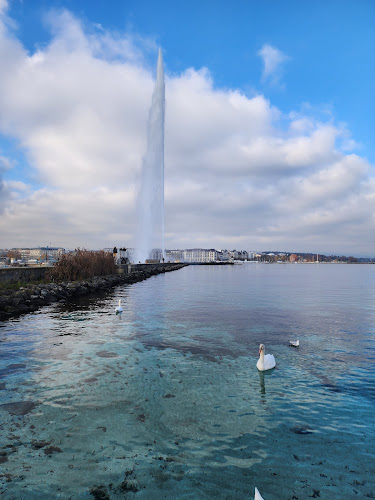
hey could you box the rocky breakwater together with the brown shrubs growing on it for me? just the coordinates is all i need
[0,250,186,321]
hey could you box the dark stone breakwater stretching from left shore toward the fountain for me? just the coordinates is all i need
[0,264,186,320]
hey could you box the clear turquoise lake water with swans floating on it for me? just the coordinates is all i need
[0,263,375,500]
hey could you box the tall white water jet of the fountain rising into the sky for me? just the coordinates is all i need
[134,49,165,262]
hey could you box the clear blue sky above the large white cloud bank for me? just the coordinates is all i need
[10,0,375,162]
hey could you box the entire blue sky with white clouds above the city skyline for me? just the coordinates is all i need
[0,0,375,257]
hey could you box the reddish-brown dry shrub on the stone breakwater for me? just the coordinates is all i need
[48,249,116,281]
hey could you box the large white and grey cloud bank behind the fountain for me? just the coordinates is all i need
[0,8,375,254]
